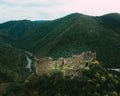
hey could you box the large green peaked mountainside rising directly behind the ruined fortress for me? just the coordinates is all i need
[16,13,120,67]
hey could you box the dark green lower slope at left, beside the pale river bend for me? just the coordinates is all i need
[0,43,31,82]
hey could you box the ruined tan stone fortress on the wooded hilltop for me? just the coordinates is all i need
[36,51,96,77]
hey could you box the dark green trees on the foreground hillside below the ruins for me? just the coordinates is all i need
[2,64,120,96]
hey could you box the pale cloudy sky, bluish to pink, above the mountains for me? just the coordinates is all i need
[0,0,120,23]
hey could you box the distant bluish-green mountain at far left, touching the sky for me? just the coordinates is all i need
[0,20,45,43]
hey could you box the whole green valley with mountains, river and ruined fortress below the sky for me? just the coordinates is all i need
[0,13,120,96]
